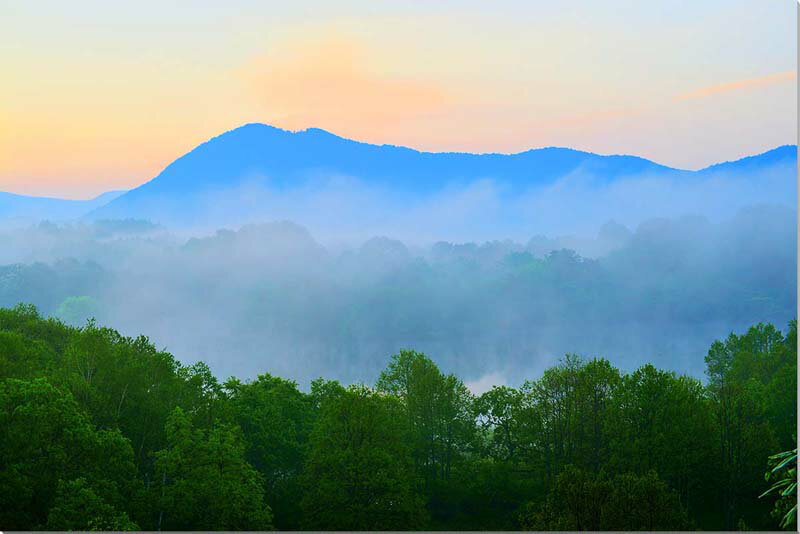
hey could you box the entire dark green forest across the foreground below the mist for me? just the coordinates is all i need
[0,304,797,530]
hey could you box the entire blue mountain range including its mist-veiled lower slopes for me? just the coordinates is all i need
[6,124,797,231]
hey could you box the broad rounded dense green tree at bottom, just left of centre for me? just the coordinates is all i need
[302,386,425,530]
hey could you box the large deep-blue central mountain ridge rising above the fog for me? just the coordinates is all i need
[95,124,667,199]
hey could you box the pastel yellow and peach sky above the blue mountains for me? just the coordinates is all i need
[0,0,797,198]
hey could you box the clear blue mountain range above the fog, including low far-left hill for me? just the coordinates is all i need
[0,124,797,225]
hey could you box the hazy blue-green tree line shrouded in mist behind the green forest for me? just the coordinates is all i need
[0,206,797,390]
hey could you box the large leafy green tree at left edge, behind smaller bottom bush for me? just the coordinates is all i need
[0,379,138,530]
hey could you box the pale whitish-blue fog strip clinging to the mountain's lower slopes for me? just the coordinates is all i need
[101,160,797,247]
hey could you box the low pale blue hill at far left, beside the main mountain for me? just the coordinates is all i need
[0,191,125,224]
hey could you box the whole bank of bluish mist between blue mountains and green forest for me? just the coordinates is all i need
[0,182,797,391]
